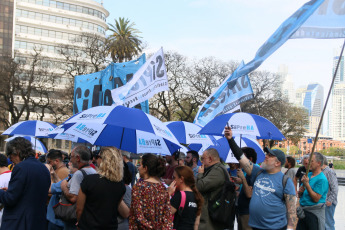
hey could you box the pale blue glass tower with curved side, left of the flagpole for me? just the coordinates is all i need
[303,84,323,133]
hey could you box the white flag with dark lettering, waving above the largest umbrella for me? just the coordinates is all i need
[111,48,169,107]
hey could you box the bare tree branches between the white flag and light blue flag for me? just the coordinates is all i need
[150,52,235,122]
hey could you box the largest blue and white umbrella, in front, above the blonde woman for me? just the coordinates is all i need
[57,106,182,155]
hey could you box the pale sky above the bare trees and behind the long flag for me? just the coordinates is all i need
[103,0,343,95]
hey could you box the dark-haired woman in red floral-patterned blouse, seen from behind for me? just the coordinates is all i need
[129,153,172,230]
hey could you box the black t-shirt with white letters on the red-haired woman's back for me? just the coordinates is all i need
[170,191,198,230]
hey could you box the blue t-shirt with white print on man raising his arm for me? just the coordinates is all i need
[249,165,296,229]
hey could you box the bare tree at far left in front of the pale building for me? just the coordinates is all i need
[0,48,58,128]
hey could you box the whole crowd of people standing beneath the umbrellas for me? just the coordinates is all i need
[0,127,338,230]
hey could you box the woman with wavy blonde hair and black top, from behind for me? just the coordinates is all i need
[77,147,126,229]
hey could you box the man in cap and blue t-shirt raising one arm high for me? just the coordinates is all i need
[224,127,297,230]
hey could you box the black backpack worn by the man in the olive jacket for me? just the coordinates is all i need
[207,168,236,229]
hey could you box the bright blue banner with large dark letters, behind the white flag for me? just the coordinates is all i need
[73,54,149,114]
